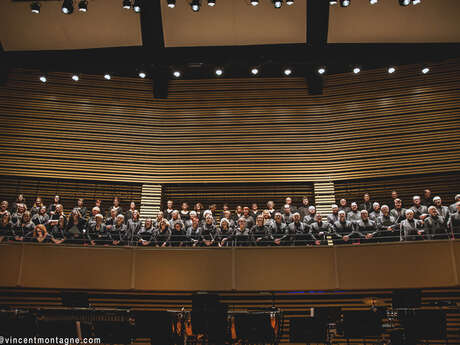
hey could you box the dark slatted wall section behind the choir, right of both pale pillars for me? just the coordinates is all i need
[335,173,460,208]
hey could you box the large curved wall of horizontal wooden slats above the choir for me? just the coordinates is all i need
[0,60,460,184]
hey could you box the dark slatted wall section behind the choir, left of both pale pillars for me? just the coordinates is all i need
[0,176,142,215]
